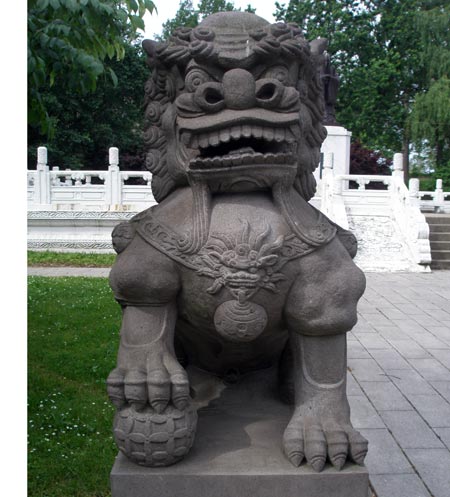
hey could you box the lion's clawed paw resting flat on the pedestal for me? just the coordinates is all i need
[283,414,368,471]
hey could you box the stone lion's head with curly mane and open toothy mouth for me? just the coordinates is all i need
[143,12,326,201]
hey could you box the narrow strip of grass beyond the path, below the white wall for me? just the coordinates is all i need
[28,251,116,267]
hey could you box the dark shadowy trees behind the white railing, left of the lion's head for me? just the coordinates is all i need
[28,40,149,169]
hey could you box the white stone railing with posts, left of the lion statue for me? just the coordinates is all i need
[27,147,156,211]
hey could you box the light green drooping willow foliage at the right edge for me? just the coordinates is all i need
[408,1,450,187]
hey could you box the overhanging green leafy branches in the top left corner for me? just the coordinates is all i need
[28,0,154,134]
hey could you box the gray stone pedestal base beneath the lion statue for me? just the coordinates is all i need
[111,372,369,497]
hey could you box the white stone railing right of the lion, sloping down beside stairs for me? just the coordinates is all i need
[321,154,431,265]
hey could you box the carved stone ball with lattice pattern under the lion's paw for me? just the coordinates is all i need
[113,406,197,467]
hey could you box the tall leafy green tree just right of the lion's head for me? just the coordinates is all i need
[276,0,424,170]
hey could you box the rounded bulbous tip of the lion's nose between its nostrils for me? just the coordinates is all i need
[222,69,256,109]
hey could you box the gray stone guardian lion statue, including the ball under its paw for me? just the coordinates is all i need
[107,12,367,471]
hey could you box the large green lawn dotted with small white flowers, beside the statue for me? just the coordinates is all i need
[28,277,120,497]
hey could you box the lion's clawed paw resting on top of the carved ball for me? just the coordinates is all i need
[107,347,189,413]
